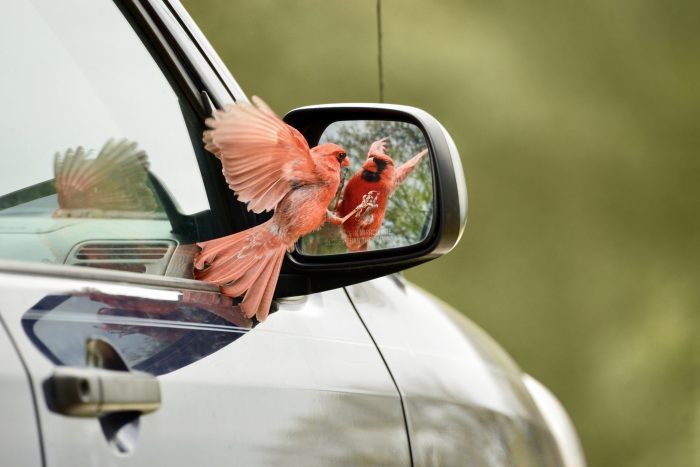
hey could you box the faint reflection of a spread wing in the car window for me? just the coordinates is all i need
[54,139,156,212]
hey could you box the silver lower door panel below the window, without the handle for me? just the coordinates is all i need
[0,273,410,466]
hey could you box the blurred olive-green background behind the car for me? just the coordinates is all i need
[184,0,700,467]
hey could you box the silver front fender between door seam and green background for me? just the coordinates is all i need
[348,278,562,466]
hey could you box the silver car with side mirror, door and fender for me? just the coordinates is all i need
[0,0,585,466]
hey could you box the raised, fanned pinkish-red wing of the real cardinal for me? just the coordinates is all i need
[204,96,315,213]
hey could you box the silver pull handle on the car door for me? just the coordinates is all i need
[47,367,160,417]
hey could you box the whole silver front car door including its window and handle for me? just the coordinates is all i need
[0,0,410,466]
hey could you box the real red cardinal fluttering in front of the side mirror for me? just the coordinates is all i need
[194,97,359,321]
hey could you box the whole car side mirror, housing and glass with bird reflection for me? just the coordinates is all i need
[275,104,467,297]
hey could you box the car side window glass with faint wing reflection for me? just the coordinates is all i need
[0,0,209,276]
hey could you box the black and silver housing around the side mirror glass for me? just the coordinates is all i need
[275,104,467,297]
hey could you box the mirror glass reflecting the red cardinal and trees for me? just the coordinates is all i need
[298,120,434,255]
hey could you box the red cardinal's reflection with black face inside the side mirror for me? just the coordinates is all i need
[336,138,428,251]
